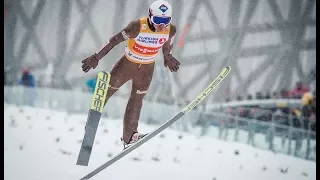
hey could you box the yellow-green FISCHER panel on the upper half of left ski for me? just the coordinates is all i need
[91,73,108,112]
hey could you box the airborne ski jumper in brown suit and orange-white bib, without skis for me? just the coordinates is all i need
[82,0,180,148]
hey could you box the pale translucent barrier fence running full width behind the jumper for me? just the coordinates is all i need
[4,86,316,161]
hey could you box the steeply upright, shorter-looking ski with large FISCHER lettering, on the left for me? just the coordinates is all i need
[77,72,111,166]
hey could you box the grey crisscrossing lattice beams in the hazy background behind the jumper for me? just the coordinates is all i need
[4,0,316,99]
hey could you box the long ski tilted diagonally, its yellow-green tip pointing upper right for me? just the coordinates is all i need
[80,66,231,180]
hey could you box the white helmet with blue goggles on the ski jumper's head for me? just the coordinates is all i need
[149,0,172,25]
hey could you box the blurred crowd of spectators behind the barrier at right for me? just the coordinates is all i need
[225,82,316,131]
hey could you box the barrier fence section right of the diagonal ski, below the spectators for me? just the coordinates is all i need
[181,112,316,161]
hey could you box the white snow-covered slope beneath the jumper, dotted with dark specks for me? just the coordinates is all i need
[4,104,316,180]
